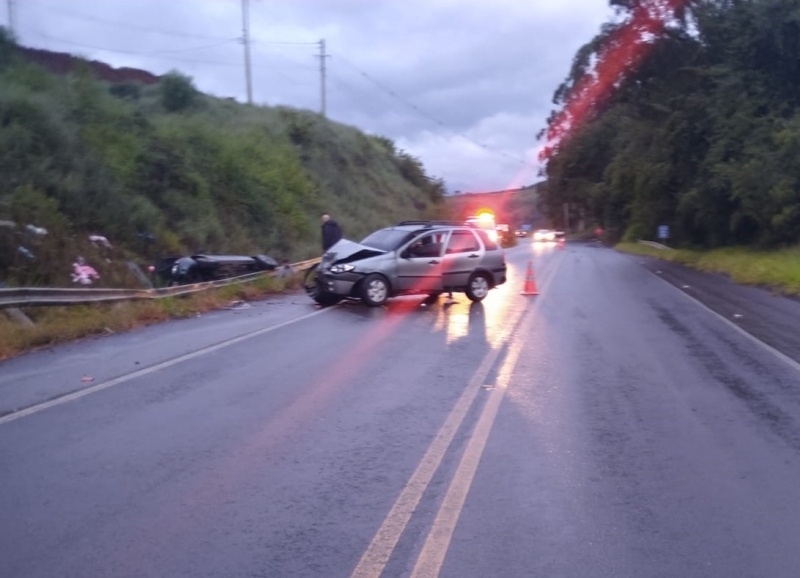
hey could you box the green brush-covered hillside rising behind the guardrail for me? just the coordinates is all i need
[0,28,444,286]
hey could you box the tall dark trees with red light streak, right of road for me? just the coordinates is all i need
[545,0,800,247]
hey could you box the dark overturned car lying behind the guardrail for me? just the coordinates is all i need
[155,255,278,286]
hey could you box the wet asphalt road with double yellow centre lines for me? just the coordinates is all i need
[0,243,800,578]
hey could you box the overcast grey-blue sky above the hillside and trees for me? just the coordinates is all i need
[0,0,613,192]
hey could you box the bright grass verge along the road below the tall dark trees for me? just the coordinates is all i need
[616,243,800,296]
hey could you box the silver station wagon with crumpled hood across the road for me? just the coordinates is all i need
[305,221,506,307]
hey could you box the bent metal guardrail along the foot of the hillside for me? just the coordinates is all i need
[0,257,320,309]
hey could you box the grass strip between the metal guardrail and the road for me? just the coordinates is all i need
[0,274,301,360]
